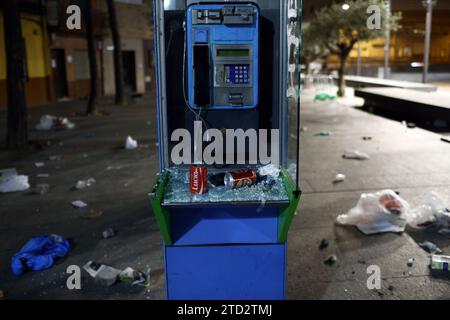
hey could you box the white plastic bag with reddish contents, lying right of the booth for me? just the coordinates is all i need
[337,190,410,234]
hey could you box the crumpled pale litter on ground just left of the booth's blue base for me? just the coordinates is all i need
[83,261,150,287]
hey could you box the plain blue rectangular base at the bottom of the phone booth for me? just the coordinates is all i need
[165,243,286,300]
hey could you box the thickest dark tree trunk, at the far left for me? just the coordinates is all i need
[3,0,28,149]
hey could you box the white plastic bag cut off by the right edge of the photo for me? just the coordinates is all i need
[407,191,450,229]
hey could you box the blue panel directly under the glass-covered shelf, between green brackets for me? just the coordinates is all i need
[171,206,278,245]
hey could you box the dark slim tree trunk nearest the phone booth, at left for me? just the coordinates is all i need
[106,0,127,106]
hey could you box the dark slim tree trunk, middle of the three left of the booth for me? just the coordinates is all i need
[84,0,98,115]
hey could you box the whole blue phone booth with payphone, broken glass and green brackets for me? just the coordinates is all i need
[150,0,301,300]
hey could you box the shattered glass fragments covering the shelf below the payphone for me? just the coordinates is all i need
[163,168,289,204]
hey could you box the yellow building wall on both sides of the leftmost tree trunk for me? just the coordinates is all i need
[0,14,49,80]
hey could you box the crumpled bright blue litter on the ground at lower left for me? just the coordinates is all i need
[11,234,70,276]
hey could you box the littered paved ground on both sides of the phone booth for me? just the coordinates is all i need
[0,91,450,299]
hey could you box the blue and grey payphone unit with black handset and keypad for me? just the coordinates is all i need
[185,4,259,110]
